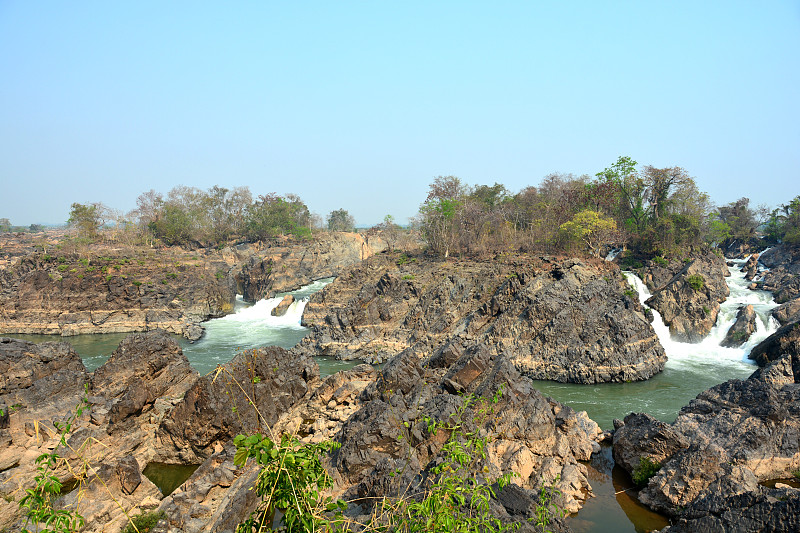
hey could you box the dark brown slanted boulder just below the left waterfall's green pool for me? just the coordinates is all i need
[159,346,319,463]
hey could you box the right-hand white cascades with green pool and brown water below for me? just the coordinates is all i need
[564,252,778,533]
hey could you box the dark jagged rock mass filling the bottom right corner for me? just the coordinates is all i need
[614,353,800,532]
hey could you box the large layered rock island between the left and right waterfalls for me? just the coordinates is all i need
[293,256,666,383]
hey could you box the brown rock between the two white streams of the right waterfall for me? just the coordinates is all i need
[642,251,730,342]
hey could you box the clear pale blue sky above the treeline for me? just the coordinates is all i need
[0,0,800,225]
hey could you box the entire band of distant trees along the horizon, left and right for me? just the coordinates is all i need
[0,157,800,257]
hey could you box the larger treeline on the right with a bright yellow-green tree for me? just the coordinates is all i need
[417,157,800,257]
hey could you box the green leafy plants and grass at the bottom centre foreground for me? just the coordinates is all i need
[234,386,565,533]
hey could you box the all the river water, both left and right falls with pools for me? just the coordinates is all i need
[3,260,778,533]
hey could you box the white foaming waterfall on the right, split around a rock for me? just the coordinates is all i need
[623,250,779,368]
